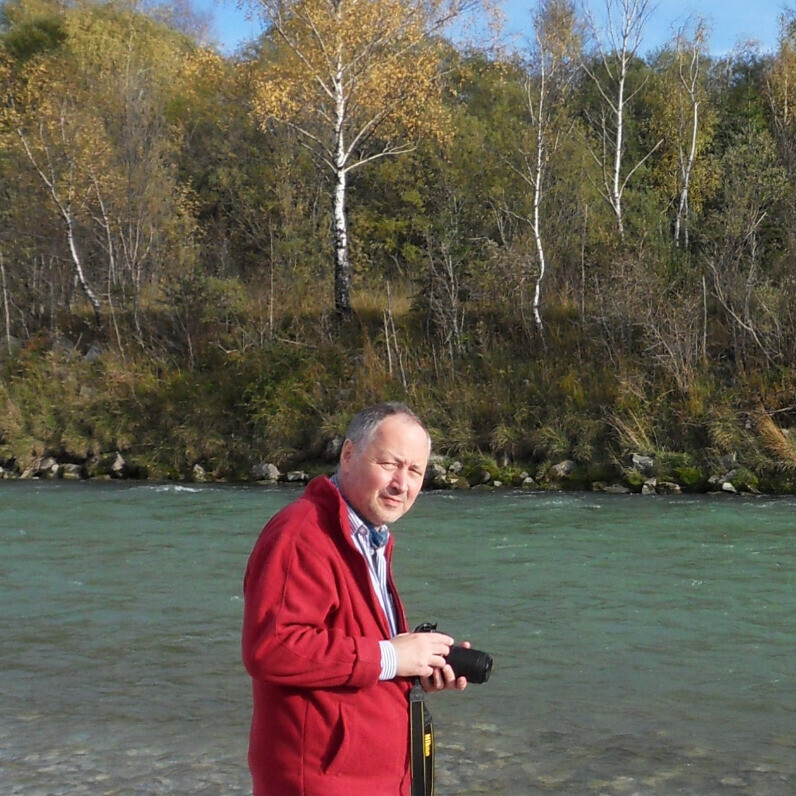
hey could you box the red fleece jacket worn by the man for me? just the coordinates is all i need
[243,477,411,796]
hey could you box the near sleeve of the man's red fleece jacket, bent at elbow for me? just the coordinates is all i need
[242,510,381,688]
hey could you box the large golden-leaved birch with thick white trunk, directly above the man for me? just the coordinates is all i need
[253,0,475,317]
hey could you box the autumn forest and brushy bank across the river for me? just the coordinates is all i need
[0,0,796,494]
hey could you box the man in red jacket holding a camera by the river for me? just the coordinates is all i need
[243,404,467,796]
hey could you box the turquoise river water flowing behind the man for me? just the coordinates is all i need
[0,482,796,796]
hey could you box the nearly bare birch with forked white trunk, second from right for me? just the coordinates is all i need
[583,0,662,238]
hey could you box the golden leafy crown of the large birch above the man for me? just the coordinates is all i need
[252,0,460,154]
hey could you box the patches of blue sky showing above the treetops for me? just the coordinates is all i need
[194,0,796,55]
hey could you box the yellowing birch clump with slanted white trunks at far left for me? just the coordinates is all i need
[2,3,205,342]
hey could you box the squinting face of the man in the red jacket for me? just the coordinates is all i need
[337,415,429,525]
